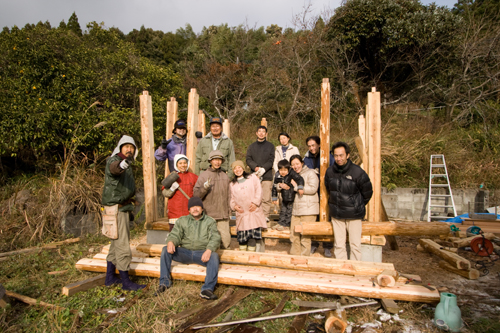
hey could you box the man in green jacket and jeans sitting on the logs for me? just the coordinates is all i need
[156,197,220,300]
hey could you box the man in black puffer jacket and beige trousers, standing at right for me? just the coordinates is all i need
[325,142,373,261]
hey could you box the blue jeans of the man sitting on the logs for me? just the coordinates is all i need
[160,246,219,291]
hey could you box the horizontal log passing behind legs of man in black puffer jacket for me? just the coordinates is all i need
[295,221,449,236]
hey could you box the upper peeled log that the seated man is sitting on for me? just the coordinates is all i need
[135,244,397,275]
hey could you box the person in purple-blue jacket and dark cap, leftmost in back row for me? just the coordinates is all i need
[155,119,187,172]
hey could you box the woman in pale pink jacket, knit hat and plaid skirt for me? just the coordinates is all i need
[230,161,267,252]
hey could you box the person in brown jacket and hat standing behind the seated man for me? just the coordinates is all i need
[193,150,231,249]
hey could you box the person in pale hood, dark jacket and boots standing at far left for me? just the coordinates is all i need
[102,135,145,290]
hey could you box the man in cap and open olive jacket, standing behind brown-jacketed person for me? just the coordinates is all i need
[195,117,235,179]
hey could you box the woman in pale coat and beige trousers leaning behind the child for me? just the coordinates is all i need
[285,155,319,256]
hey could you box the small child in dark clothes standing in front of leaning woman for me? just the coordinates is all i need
[272,160,304,231]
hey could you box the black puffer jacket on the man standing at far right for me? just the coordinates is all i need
[325,159,373,220]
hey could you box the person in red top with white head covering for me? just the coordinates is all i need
[162,154,198,230]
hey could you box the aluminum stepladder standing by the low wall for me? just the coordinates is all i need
[427,155,457,222]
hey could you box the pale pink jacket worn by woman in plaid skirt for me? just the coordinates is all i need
[229,174,267,231]
